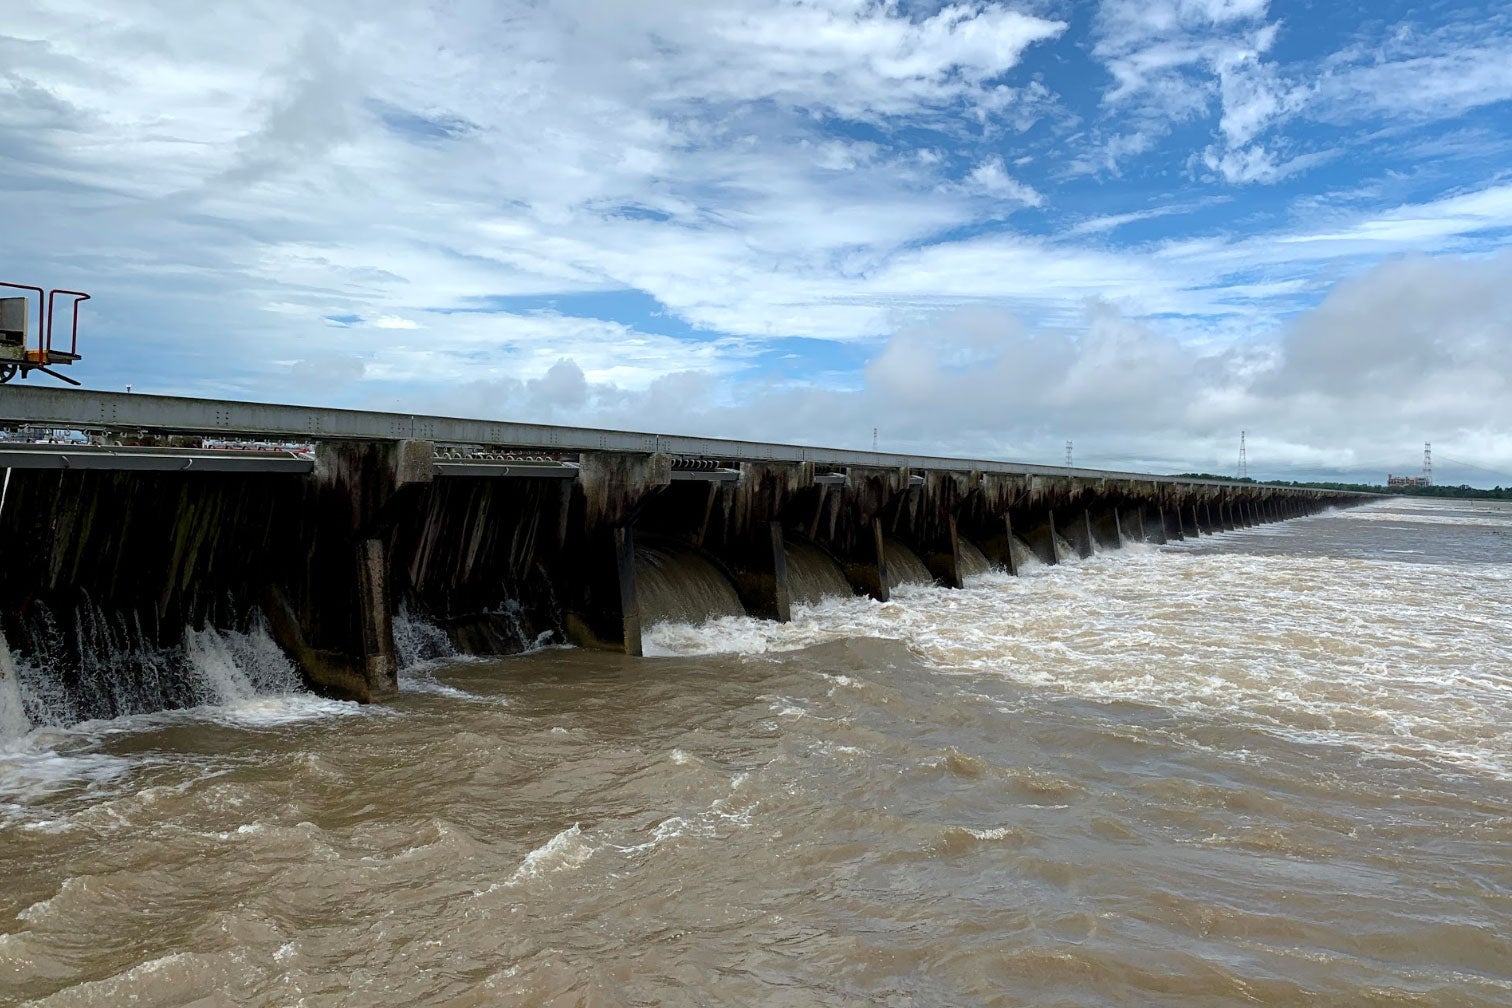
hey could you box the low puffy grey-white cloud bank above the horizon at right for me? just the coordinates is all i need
[393,254,1512,482]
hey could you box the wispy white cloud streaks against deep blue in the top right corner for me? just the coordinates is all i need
[1084,0,1512,184]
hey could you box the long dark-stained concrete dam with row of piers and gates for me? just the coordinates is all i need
[0,387,1367,718]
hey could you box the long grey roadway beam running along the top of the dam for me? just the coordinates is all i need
[0,385,1329,494]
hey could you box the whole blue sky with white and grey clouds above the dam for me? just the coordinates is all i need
[0,0,1512,485]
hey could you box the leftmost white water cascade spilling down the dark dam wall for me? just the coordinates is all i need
[0,598,304,739]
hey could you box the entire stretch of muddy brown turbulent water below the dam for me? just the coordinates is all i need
[0,502,1512,1006]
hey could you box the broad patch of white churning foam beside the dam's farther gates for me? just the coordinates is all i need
[635,511,1512,778]
